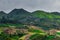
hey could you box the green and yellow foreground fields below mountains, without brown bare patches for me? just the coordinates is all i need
[0,24,60,40]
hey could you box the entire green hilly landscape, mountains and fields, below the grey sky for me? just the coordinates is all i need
[0,9,60,40]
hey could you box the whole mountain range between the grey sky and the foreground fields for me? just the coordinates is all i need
[0,9,60,29]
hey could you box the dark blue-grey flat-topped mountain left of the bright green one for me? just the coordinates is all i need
[5,8,30,23]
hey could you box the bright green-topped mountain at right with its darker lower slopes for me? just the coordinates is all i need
[31,10,60,29]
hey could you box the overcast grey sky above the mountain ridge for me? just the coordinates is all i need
[0,0,60,12]
